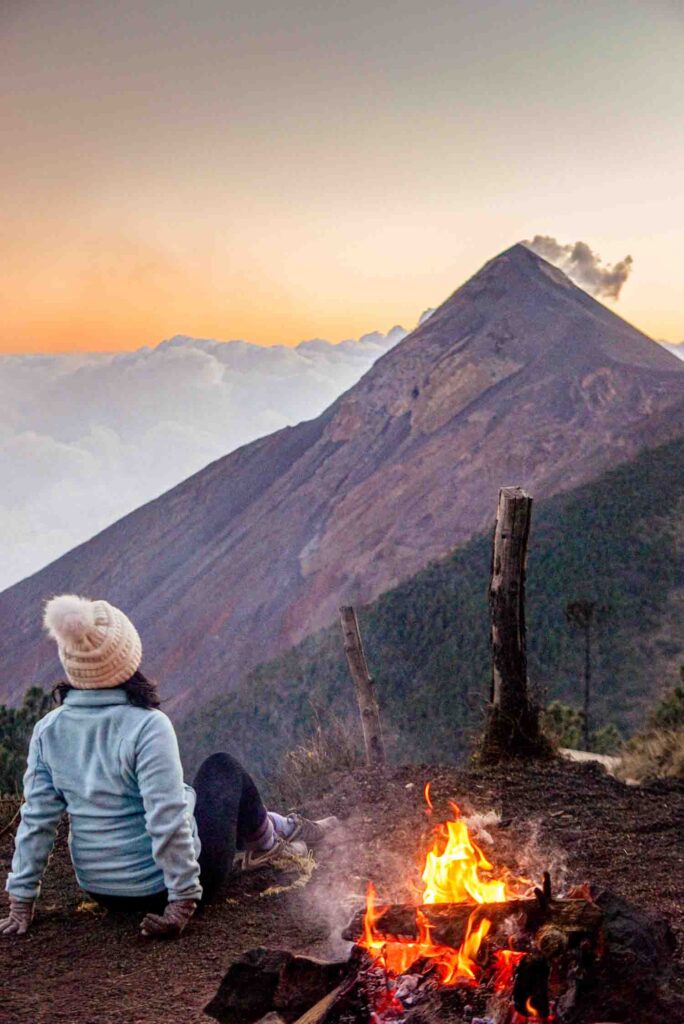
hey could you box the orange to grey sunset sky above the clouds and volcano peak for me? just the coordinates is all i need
[0,0,684,353]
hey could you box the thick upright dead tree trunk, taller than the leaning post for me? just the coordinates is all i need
[482,487,547,761]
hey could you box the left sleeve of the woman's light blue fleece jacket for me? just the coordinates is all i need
[5,723,67,899]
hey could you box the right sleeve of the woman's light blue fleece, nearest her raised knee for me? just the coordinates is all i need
[134,711,202,901]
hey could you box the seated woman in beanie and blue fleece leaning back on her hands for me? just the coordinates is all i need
[0,594,336,937]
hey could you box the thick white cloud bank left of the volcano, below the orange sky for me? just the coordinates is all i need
[0,327,407,589]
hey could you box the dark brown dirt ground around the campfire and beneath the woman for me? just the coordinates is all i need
[0,762,684,1024]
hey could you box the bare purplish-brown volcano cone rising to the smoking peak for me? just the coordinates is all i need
[0,246,684,711]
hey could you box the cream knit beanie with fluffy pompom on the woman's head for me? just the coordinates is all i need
[43,594,142,690]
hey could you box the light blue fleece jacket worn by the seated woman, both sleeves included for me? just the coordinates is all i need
[5,687,202,900]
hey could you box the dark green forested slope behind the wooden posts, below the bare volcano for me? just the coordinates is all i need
[180,439,684,772]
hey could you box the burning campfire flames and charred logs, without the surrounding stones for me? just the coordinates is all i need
[347,783,581,1024]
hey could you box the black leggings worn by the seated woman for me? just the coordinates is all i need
[90,754,266,913]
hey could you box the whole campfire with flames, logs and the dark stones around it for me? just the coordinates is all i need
[207,785,672,1024]
